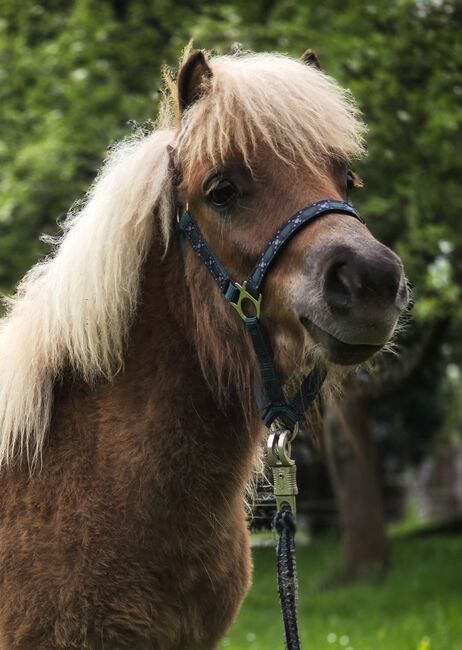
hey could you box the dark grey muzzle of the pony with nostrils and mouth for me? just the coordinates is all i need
[297,233,409,365]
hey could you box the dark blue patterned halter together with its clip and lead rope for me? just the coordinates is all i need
[178,199,364,650]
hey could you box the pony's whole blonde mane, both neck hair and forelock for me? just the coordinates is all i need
[0,54,363,465]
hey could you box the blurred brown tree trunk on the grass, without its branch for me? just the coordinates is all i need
[324,395,388,579]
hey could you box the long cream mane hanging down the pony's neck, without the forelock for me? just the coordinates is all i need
[0,130,174,464]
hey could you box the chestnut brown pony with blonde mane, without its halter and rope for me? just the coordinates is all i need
[0,50,408,650]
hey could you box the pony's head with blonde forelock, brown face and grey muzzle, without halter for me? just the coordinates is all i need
[172,51,408,378]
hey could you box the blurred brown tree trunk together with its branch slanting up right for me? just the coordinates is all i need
[323,314,451,578]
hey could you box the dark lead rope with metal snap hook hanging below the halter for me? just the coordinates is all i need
[267,422,300,650]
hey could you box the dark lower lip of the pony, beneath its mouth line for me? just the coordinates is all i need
[300,316,383,366]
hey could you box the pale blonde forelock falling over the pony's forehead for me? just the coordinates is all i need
[170,54,365,175]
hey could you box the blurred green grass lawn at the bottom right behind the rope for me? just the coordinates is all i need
[221,536,462,650]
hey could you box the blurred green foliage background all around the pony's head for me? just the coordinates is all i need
[0,0,462,435]
